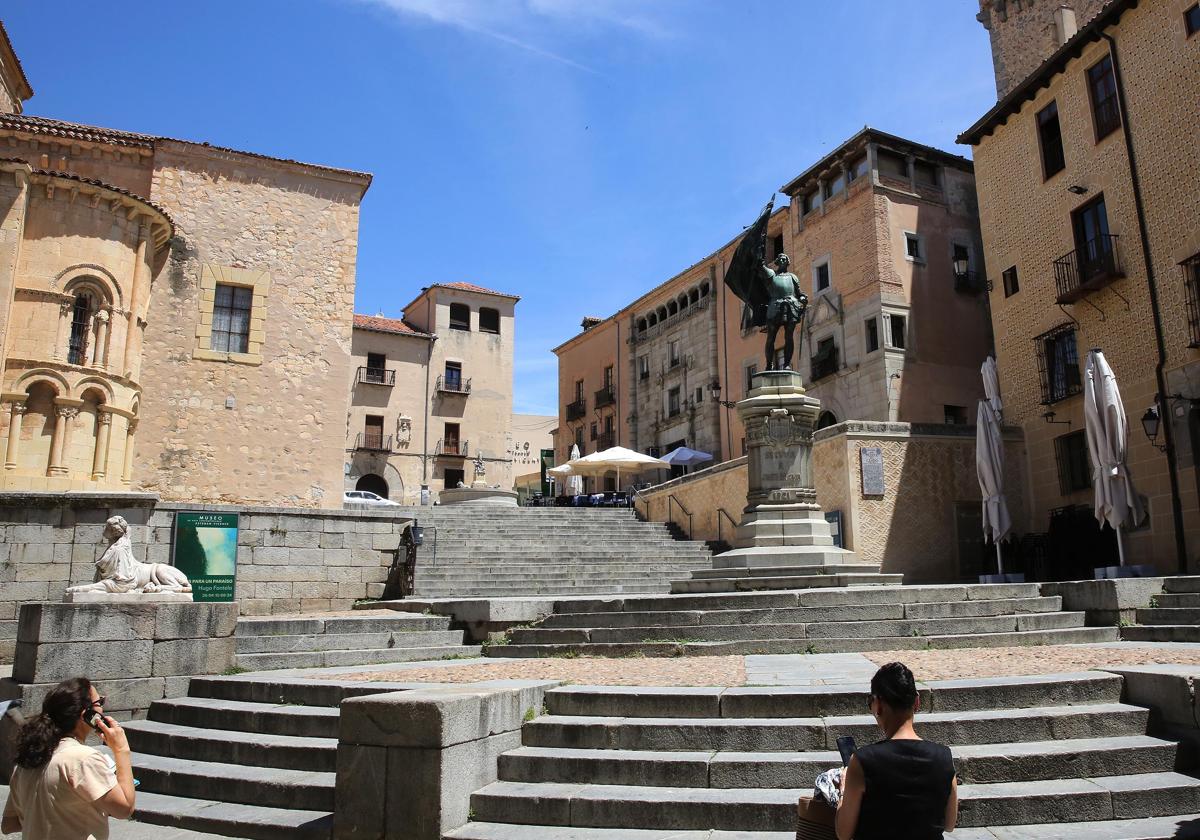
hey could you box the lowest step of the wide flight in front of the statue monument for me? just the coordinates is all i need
[487,625,1118,658]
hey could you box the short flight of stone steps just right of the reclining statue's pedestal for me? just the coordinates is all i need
[234,612,480,671]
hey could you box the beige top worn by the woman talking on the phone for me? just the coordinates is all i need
[5,736,116,840]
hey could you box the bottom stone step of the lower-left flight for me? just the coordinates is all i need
[130,791,334,840]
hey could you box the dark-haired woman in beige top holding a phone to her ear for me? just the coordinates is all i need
[0,677,133,840]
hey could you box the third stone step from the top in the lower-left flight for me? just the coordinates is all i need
[124,720,337,773]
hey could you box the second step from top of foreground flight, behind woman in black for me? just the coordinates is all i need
[521,703,1148,752]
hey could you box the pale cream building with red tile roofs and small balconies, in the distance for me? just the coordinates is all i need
[346,282,523,504]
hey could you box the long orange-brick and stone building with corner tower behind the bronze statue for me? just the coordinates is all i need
[554,128,990,475]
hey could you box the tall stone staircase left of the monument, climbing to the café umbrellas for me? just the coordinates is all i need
[412,505,712,599]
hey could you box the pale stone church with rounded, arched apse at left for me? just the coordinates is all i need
[0,22,371,506]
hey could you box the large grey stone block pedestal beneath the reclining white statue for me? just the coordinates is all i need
[0,593,238,779]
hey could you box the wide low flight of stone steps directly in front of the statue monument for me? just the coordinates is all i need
[487,583,1118,658]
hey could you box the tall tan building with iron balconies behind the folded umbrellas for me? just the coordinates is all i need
[959,0,1200,572]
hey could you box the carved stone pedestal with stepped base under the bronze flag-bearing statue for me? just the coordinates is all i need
[671,371,904,593]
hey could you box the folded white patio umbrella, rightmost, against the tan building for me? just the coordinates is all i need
[1084,349,1146,565]
